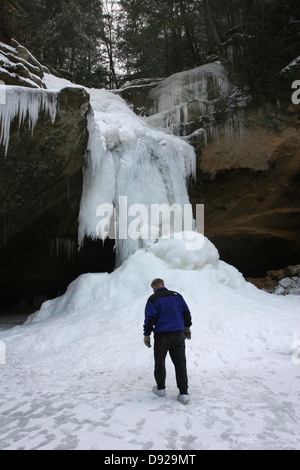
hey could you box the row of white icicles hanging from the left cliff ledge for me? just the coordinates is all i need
[0,86,57,155]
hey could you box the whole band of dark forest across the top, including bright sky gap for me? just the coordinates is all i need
[0,0,300,99]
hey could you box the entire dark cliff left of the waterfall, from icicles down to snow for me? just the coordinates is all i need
[0,75,113,311]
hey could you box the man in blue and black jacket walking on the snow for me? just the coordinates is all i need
[144,279,192,403]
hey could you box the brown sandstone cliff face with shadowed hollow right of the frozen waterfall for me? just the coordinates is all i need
[191,105,300,276]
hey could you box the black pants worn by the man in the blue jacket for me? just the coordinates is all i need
[154,331,188,395]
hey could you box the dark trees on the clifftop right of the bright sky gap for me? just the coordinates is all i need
[119,0,300,99]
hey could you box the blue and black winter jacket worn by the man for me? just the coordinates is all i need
[144,287,192,336]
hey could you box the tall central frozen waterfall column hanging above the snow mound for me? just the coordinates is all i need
[79,90,196,265]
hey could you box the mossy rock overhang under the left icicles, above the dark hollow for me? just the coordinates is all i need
[0,88,89,239]
